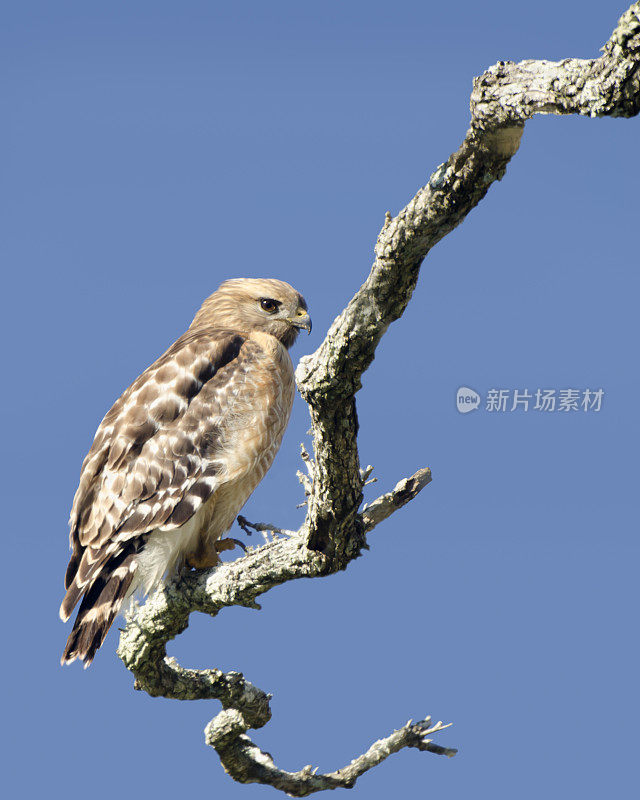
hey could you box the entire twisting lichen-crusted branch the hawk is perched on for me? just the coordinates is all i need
[119,3,640,797]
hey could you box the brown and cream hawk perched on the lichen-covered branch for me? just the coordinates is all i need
[60,278,311,667]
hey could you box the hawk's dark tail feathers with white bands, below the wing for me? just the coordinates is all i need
[60,540,140,668]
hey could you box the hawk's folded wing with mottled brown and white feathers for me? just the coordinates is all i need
[65,329,262,600]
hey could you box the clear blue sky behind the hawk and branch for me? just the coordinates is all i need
[0,0,640,800]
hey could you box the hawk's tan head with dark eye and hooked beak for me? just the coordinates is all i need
[191,278,311,347]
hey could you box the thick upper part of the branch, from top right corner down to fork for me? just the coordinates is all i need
[296,2,640,566]
